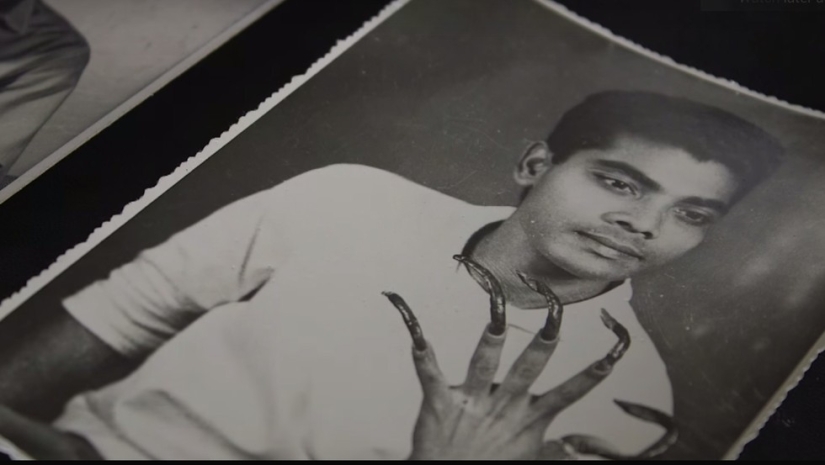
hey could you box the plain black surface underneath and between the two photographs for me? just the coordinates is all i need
[0,0,825,460]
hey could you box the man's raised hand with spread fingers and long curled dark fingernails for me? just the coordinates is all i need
[385,256,675,460]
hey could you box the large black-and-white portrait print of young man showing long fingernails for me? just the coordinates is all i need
[0,0,825,460]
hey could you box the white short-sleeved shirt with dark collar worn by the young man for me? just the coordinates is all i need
[55,165,672,459]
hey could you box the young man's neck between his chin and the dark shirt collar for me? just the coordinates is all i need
[463,217,616,309]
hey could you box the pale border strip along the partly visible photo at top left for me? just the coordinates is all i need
[0,0,284,204]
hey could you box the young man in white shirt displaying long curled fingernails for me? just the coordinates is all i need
[0,91,782,459]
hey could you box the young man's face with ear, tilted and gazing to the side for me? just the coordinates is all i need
[514,132,737,280]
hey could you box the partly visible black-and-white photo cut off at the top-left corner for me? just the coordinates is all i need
[0,0,281,202]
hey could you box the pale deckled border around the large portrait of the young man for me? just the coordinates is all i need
[0,0,825,460]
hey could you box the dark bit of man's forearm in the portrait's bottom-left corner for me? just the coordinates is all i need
[0,405,103,460]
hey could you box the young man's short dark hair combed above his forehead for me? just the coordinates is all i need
[532,91,784,202]
